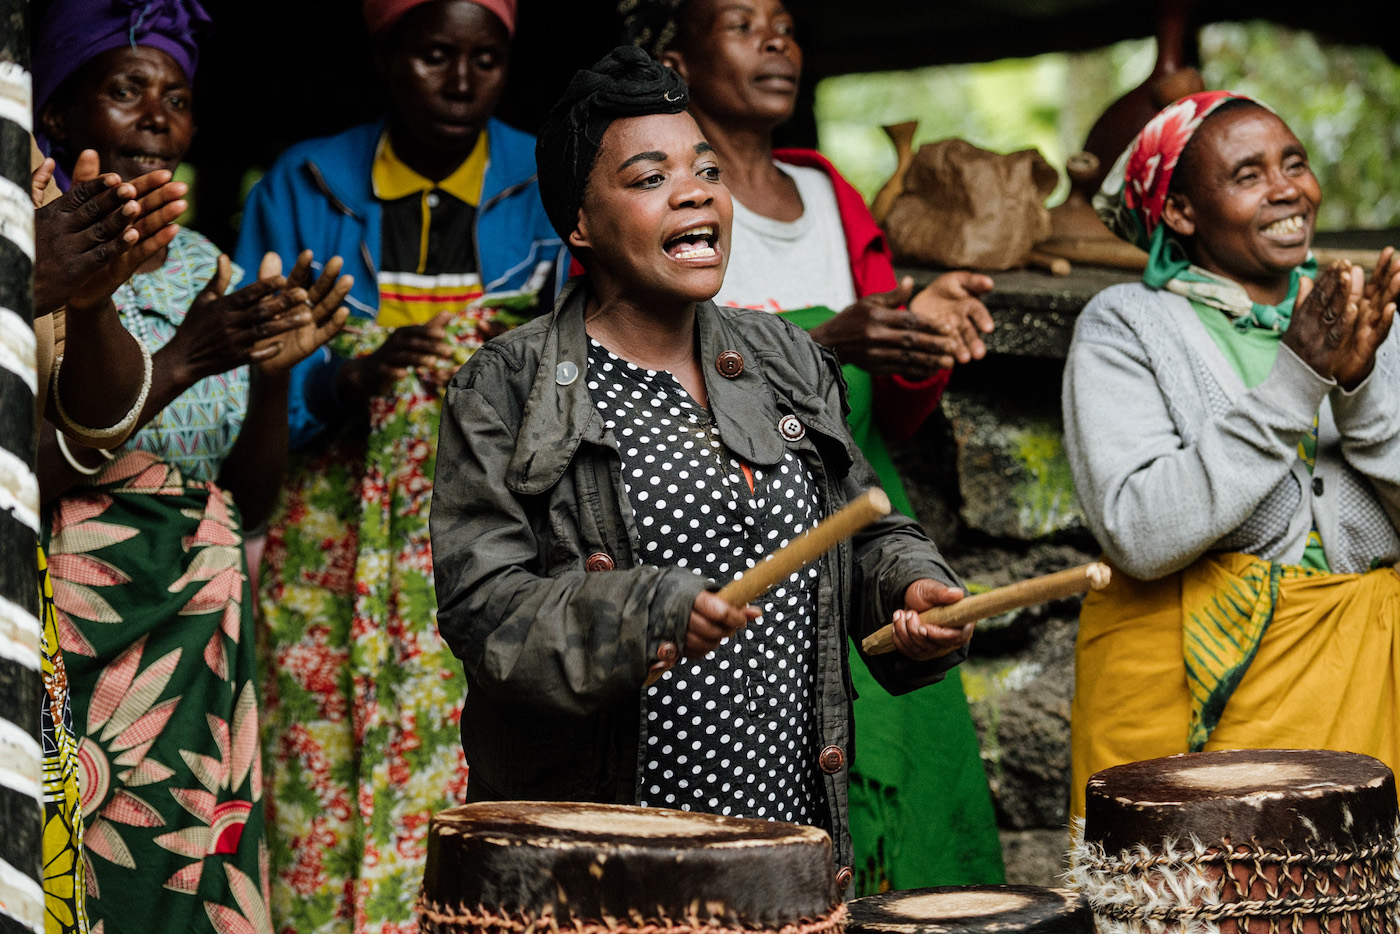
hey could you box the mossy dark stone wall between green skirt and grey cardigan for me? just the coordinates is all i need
[893,261,1130,885]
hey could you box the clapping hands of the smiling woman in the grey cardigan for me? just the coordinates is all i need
[1282,248,1400,389]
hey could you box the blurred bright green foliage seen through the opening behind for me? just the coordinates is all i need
[816,22,1400,230]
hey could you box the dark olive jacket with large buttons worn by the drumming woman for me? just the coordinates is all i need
[431,280,965,865]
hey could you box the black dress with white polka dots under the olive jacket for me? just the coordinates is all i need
[588,340,825,823]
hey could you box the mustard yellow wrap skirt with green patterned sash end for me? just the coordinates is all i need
[1071,553,1400,816]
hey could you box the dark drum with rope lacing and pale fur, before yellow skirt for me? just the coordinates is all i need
[1070,749,1400,934]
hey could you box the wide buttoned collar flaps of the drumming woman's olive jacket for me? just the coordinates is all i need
[505,276,787,496]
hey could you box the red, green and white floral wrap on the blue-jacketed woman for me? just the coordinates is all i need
[260,317,479,934]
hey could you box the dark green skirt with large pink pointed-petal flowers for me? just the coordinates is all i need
[48,451,270,934]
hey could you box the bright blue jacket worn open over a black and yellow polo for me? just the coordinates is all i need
[234,119,567,448]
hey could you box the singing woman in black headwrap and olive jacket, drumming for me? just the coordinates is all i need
[431,49,970,886]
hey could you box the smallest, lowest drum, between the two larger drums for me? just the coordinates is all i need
[846,885,1093,934]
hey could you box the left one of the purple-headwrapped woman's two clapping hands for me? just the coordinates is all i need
[161,253,312,385]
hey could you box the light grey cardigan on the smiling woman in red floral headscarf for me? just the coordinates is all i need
[1063,284,1400,580]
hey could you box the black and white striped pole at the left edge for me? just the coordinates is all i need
[0,0,43,934]
